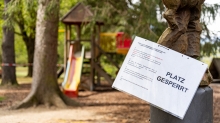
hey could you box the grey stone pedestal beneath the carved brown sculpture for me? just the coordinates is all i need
[150,86,213,123]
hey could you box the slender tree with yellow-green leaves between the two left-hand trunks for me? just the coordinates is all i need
[6,0,37,77]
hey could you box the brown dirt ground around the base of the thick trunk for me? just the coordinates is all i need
[0,84,220,123]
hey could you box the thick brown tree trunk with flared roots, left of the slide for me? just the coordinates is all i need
[14,0,76,108]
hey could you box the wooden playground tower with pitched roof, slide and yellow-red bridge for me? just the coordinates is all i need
[58,3,132,97]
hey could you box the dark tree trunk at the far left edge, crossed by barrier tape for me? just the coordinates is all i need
[1,0,18,85]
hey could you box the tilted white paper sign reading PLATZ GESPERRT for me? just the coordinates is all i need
[112,37,207,119]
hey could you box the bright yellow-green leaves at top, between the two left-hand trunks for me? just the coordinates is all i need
[4,0,37,37]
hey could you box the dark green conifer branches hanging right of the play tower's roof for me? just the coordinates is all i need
[83,0,166,41]
